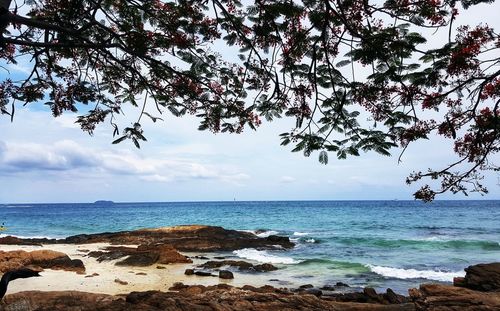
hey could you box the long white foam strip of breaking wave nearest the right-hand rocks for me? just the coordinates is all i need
[367,265,465,282]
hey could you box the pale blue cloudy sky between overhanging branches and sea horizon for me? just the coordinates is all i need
[0,4,500,203]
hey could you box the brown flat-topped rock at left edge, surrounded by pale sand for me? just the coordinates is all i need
[0,250,85,274]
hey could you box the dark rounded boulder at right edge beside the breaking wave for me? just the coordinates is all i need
[464,262,500,292]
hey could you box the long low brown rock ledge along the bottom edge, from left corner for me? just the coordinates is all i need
[0,284,414,311]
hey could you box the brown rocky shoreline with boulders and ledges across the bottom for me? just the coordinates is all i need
[0,226,500,311]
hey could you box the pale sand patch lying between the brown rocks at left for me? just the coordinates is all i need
[0,243,278,294]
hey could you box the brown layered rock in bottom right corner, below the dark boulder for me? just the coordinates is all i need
[409,284,500,311]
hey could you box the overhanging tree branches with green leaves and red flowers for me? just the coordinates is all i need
[0,0,500,200]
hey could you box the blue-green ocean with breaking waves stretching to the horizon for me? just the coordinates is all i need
[0,201,500,294]
